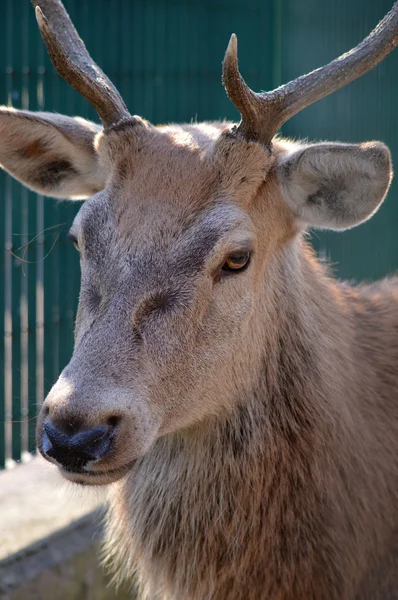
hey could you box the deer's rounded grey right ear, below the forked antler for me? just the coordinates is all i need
[278,142,392,229]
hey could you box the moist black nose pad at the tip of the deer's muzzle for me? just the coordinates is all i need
[41,417,116,471]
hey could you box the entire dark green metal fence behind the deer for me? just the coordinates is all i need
[0,0,398,468]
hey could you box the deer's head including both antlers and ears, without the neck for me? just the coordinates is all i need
[0,0,398,484]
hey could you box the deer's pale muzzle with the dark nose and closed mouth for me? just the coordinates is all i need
[36,370,162,485]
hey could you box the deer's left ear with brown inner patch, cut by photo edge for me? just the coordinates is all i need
[0,107,105,199]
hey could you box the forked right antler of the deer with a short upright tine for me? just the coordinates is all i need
[223,1,398,144]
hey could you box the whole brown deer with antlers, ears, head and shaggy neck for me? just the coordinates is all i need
[0,0,398,600]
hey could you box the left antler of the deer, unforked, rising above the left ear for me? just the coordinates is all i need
[32,0,130,128]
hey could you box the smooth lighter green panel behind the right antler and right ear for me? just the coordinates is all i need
[282,0,398,280]
